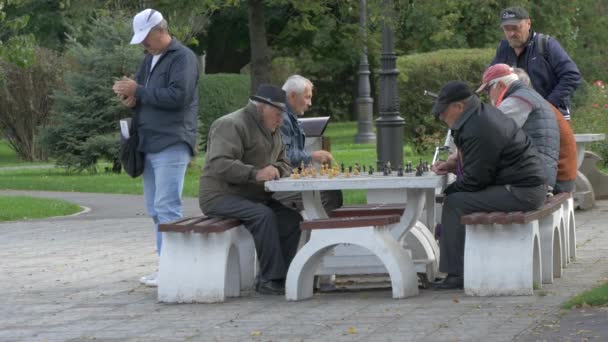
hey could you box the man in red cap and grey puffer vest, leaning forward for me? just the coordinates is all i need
[477,64,559,188]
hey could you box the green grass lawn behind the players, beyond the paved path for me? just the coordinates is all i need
[0,122,432,204]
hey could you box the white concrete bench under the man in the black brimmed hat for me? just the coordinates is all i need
[158,215,256,303]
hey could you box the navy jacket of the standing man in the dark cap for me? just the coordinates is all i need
[490,30,581,120]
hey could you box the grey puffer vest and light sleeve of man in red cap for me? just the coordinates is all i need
[498,81,560,187]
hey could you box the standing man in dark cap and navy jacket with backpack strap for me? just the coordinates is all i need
[490,7,581,120]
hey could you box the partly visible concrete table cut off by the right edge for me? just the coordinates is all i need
[574,134,606,210]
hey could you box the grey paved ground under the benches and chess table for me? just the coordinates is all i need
[0,191,608,341]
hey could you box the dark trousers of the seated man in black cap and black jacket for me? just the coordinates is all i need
[439,185,547,276]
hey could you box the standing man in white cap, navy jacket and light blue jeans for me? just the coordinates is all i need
[112,9,199,286]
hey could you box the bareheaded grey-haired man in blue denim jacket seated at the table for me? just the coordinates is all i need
[274,75,342,212]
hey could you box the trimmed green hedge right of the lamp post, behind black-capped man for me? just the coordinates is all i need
[396,48,495,153]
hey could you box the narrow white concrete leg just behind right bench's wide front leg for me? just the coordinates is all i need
[539,207,563,284]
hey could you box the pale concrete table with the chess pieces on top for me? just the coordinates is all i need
[265,172,446,280]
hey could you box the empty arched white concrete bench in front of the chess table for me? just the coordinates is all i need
[285,215,418,301]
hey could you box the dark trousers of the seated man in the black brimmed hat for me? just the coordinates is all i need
[205,196,302,280]
